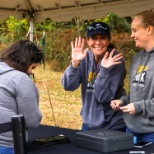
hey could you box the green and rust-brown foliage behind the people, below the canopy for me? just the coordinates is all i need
[0,12,135,71]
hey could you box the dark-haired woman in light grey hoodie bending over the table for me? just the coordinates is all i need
[0,40,43,154]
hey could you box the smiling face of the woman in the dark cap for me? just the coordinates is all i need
[87,34,110,57]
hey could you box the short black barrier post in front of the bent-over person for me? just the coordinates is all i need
[11,115,27,154]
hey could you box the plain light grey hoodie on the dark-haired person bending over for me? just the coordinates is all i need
[0,62,42,147]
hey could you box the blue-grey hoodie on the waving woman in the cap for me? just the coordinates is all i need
[62,49,126,129]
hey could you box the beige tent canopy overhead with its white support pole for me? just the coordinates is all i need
[0,0,154,41]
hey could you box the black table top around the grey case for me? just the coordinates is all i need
[26,125,154,154]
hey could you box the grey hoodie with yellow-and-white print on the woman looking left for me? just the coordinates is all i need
[121,49,154,133]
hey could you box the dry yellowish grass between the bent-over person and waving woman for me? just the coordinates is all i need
[34,65,82,129]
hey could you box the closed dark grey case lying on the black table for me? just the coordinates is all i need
[75,129,134,152]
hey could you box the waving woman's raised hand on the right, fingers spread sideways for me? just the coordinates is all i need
[101,49,123,68]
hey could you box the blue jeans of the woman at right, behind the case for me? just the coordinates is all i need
[126,127,154,143]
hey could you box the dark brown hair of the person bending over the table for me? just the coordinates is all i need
[0,40,43,74]
